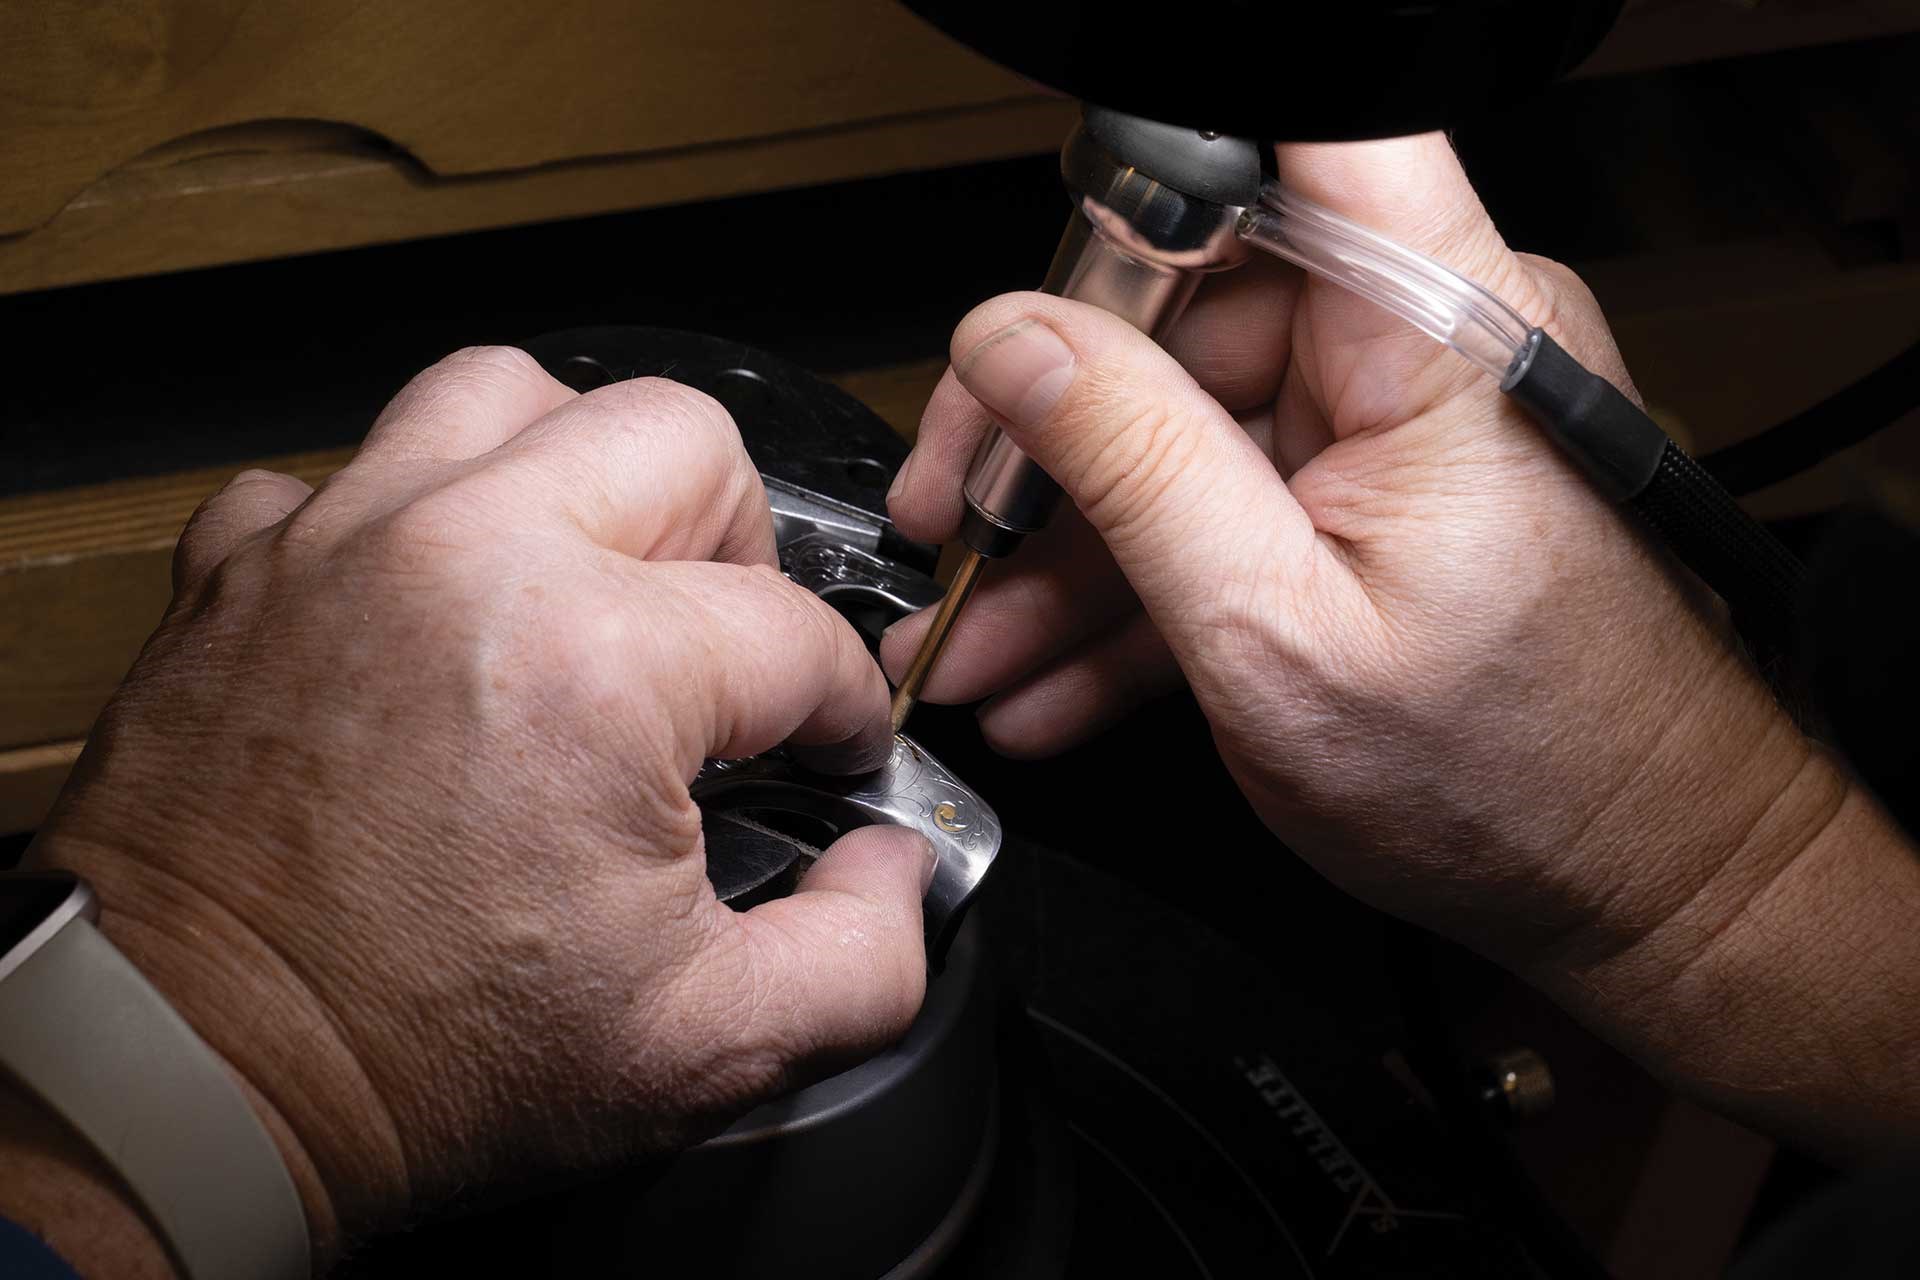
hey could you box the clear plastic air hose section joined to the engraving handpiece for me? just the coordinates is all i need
[1236,182,1532,380]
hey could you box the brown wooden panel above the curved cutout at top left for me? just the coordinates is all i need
[0,0,1033,232]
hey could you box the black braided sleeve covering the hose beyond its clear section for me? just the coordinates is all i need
[1501,330,1805,658]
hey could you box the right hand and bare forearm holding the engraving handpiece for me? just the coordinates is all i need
[881,134,1920,1151]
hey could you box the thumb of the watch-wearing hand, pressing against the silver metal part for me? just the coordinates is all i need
[739,827,933,1075]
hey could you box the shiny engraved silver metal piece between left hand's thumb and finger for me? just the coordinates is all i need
[693,737,1000,956]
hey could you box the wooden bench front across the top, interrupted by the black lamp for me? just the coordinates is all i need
[0,0,1920,294]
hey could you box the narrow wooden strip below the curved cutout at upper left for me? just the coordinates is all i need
[0,96,1075,294]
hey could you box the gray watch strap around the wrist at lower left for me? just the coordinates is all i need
[0,919,313,1280]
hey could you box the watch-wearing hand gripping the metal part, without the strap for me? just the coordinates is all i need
[29,349,931,1261]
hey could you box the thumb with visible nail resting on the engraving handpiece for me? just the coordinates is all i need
[952,294,1317,660]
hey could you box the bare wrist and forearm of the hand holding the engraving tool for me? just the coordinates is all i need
[1528,747,1920,1163]
